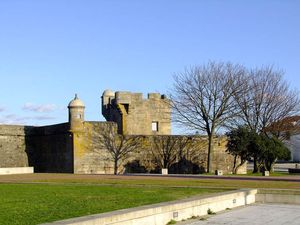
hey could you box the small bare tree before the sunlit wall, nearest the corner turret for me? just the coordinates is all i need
[98,125,144,175]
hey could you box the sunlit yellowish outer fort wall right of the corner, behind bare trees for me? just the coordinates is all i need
[73,122,246,174]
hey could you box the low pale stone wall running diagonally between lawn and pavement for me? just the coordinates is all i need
[41,189,257,225]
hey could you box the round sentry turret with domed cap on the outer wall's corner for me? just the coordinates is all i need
[68,94,85,132]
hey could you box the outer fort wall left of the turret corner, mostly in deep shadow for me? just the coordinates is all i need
[0,123,73,172]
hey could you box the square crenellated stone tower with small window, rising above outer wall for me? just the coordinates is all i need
[102,90,171,135]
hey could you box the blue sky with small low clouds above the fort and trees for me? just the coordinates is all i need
[0,0,300,130]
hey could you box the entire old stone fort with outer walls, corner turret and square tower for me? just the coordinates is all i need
[0,90,240,174]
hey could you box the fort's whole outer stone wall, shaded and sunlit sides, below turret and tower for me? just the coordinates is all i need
[0,122,245,174]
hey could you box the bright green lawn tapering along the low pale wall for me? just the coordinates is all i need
[0,184,224,225]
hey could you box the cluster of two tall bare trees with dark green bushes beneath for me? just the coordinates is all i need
[171,62,300,172]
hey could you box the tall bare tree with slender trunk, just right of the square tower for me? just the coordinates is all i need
[171,62,245,172]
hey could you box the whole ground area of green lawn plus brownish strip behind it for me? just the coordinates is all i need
[0,174,300,225]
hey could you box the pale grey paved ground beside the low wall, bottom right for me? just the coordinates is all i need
[178,204,300,225]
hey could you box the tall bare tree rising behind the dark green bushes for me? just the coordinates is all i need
[235,66,300,172]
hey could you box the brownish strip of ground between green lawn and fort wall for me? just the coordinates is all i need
[0,174,300,189]
